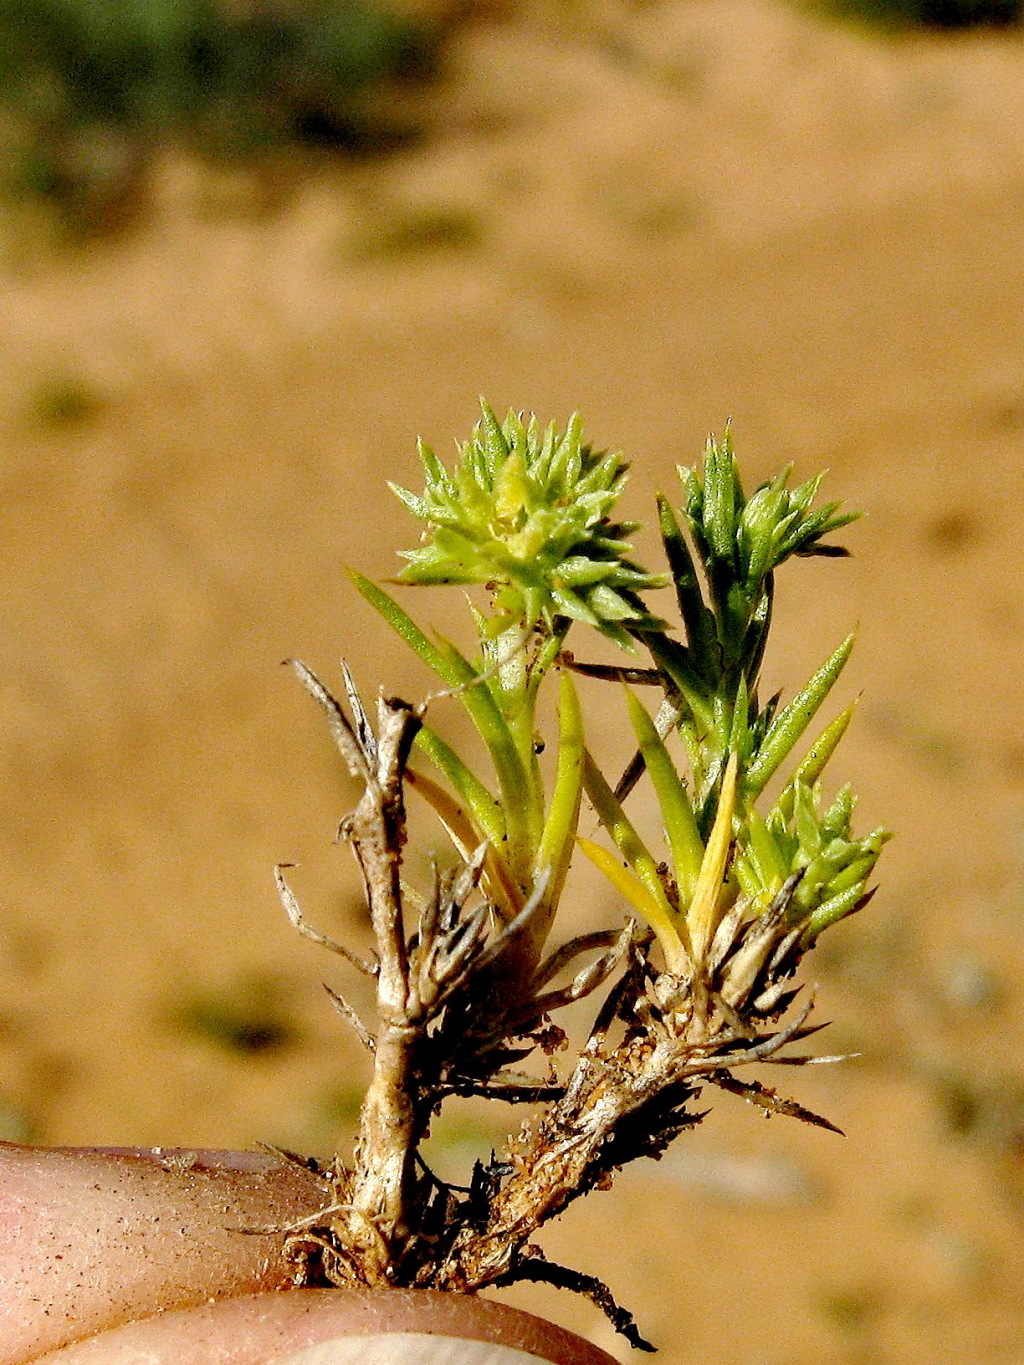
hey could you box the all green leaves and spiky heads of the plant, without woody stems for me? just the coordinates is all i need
[355,404,887,976]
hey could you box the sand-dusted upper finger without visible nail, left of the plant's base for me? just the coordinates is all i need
[0,1143,321,1365]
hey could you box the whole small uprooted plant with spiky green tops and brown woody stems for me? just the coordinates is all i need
[277,404,887,1347]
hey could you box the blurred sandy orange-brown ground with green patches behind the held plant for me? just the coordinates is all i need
[0,0,1024,1365]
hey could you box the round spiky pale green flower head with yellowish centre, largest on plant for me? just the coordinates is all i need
[390,401,666,648]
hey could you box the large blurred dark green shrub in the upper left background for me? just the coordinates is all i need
[0,0,440,227]
